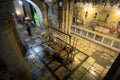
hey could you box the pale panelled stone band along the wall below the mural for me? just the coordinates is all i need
[71,25,120,52]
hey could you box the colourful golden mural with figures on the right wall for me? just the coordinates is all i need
[73,4,120,38]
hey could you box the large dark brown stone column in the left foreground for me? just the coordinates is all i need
[0,0,32,80]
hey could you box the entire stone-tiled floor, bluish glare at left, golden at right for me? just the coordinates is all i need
[18,23,118,80]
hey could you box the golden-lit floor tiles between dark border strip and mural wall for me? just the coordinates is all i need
[54,33,118,80]
